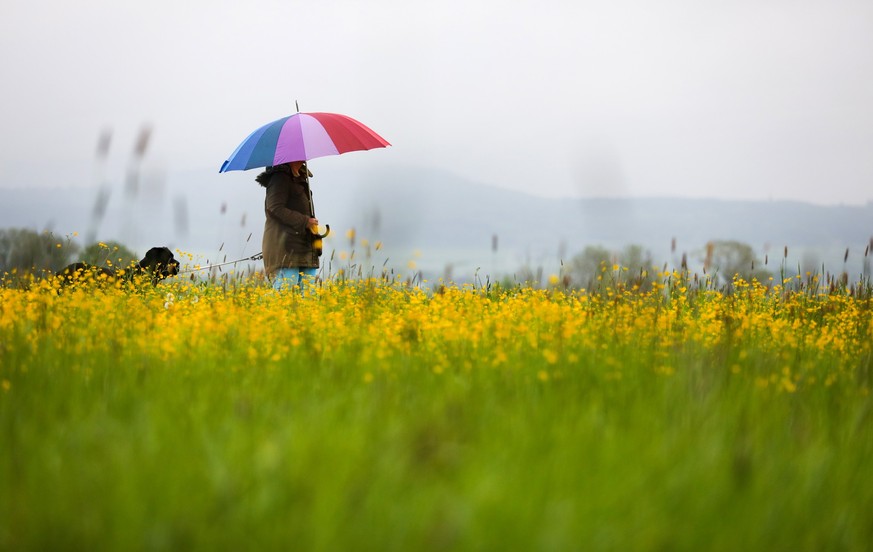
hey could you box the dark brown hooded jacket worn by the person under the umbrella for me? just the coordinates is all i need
[255,165,318,278]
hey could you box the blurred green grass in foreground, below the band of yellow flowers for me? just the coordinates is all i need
[0,278,873,551]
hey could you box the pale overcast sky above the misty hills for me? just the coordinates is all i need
[0,0,873,204]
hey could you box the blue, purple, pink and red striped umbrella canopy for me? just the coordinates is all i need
[218,113,391,172]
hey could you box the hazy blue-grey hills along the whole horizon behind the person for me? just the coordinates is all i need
[0,164,873,278]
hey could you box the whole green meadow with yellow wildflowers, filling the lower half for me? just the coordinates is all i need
[0,266,873,551]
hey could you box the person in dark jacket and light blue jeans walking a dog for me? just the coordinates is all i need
[255,161,320,291]
